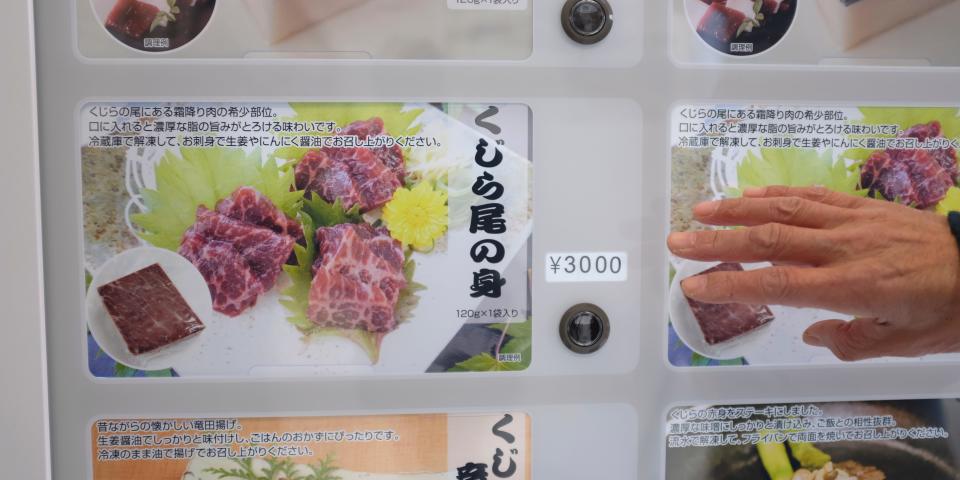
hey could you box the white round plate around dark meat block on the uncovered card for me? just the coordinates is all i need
[86,247,213,371]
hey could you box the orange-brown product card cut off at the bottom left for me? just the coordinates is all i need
[90,412,532,480]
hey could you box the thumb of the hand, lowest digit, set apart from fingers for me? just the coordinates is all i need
[803,318,889,362]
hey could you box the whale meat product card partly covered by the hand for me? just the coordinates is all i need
[667,105,960,366]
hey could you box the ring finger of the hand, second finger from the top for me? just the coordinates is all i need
[693,197,850,228]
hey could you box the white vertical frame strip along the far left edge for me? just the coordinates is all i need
[0,0,51,480]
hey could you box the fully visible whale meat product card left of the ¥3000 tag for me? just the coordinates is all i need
[78,102,532,377]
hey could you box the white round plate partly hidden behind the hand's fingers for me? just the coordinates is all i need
[669,261,778,360]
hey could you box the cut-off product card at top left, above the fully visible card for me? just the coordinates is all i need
[74,0,533,60]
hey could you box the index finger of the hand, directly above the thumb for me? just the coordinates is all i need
[681,266,851,312]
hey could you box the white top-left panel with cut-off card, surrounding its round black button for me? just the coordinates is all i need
[77,0,643,67]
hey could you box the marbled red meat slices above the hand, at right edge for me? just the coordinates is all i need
[860,121,958,208]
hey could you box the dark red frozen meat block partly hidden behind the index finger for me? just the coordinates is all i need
[687,263,774,345]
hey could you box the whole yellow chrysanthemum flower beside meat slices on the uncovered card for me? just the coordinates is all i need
[383,182,447,251]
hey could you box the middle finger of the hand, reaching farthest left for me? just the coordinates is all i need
[667,223,837,265]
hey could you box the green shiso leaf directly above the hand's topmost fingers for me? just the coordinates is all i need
[727,148,867,196]
